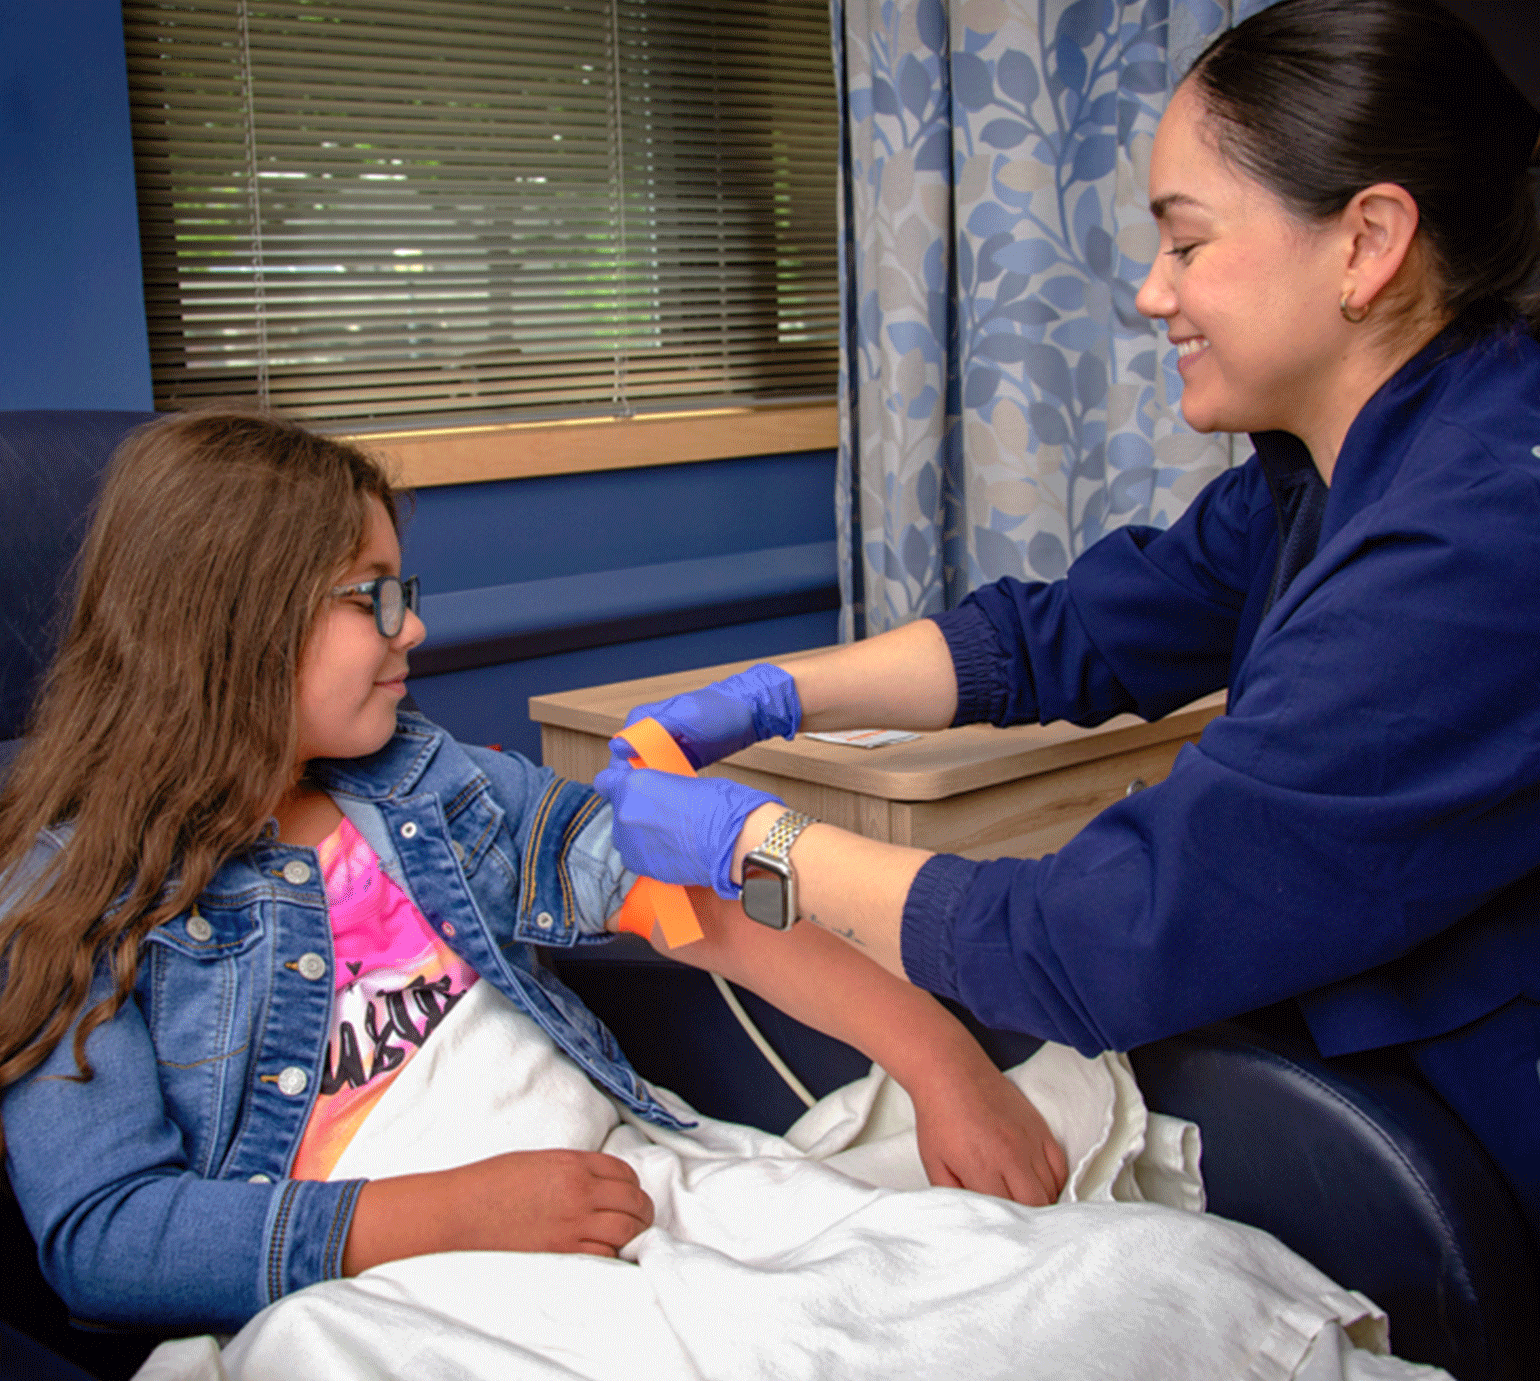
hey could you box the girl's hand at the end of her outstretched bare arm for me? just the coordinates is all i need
[910,1059,1069,1207]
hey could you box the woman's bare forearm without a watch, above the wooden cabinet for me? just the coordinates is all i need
[778,619,958,731]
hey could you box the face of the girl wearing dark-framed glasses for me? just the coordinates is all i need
[296,499,425,764]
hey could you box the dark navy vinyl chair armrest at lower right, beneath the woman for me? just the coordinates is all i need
[1132,1022,1540,1381]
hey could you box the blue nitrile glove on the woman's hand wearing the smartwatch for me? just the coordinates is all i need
[593,756,779,901]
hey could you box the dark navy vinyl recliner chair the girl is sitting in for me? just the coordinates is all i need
[0,413,1540,1381]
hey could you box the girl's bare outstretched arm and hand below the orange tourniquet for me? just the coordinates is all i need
[631,886,1066,1204]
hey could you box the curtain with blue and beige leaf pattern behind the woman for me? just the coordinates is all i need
[832,0,1267,640]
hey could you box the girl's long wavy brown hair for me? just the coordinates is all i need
[0,411,396,1088]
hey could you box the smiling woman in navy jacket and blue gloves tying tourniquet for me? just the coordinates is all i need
[598,0,1540,1239]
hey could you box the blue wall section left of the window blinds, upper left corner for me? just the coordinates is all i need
[0,0,154,410]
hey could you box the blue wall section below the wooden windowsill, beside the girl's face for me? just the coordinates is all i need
[402,451,839,762]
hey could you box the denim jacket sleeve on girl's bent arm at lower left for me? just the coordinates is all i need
[3,981,362,1332]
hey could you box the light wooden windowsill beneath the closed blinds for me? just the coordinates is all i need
[343,402,839,490]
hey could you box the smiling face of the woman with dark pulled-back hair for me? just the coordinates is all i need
[1137,83,1346,450]
